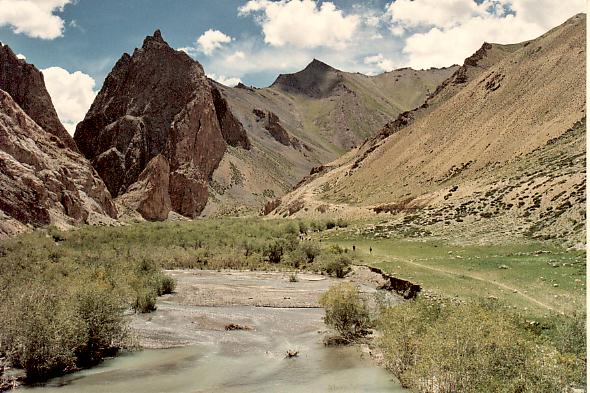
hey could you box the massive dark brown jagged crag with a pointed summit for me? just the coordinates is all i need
[74,31,250,219]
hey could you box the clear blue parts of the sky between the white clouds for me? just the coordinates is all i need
[0,0,396,86]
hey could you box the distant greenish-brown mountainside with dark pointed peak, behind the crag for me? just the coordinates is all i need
[204,60,458,214]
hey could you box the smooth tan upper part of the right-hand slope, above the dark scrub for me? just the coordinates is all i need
[330,12,586,203]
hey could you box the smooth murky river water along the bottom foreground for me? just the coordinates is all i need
[27,334,403,393]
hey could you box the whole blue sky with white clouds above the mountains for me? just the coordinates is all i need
[0,0,586,133]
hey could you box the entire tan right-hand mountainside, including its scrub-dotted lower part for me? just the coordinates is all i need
[278,15,586,245]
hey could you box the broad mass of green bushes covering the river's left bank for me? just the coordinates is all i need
[0,228,174,381]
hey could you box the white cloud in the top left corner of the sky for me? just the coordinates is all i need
[0,0,73,40]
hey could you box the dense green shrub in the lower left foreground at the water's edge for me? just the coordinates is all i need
[0,281,127,381]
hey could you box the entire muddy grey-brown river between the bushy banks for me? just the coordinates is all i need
[28,272,404,393]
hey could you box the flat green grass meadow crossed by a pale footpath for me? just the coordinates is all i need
[324,231,586,316]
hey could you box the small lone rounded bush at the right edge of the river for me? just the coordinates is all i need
[320,282,371,341]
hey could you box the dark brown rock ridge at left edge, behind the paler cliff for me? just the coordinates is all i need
[0,43,77,151]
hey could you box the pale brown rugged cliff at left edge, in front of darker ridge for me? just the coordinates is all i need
[0,90,117,237]
